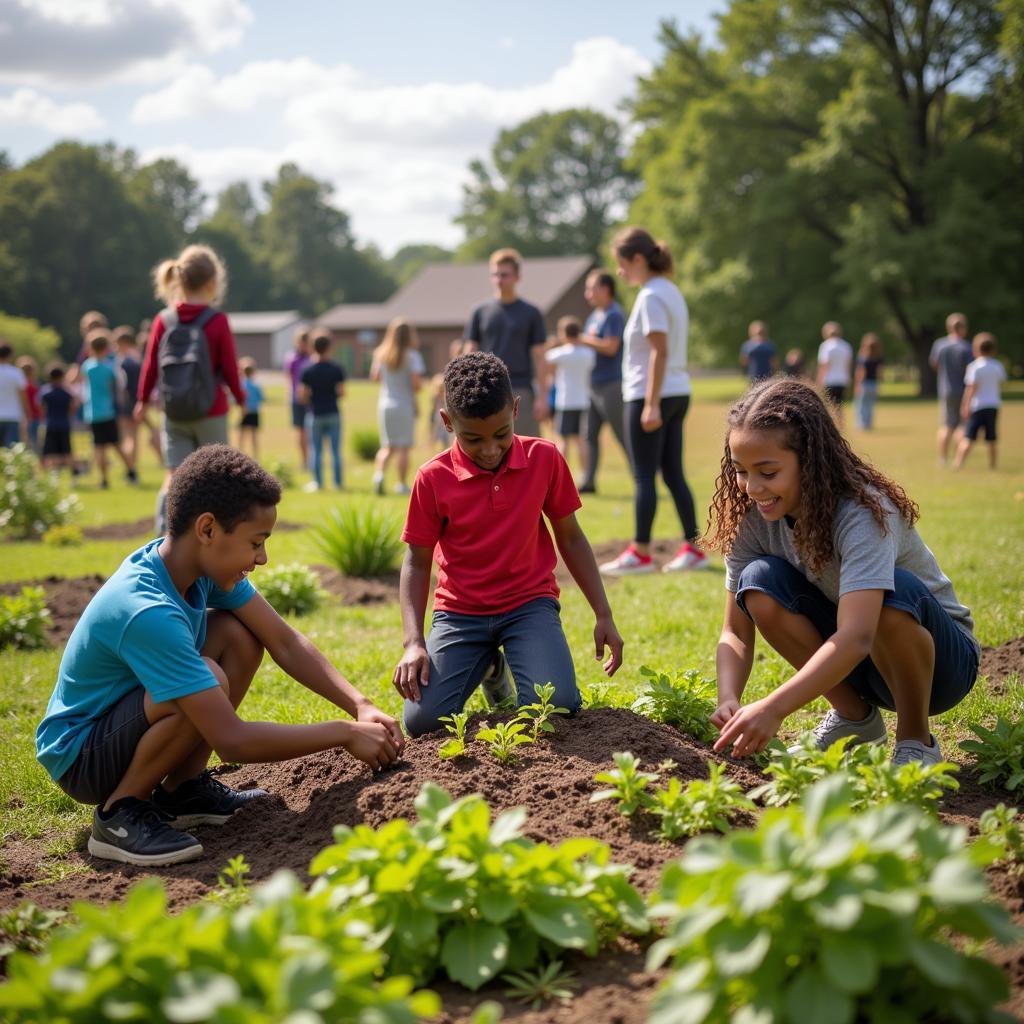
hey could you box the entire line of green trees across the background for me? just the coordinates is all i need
[0,0,1024,387]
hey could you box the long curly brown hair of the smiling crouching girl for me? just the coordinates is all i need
[705,377,919,572]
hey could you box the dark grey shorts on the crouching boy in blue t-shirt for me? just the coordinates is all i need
[57,686,150,804]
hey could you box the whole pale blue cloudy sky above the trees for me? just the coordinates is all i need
[0,0,726,255]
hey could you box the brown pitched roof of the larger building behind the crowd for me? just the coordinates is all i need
[317,256,594,331]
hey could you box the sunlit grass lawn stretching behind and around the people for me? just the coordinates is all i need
[0,377,1024,860]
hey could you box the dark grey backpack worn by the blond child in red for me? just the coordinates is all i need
[158,306,218,420]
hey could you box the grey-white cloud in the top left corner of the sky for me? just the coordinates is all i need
[0,0,253,86]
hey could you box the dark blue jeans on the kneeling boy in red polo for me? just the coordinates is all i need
[402,597,583,736]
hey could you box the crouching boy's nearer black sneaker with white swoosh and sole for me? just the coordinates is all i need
[89,797,203,867]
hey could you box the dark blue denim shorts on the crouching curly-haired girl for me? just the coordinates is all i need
[736,555,978,715]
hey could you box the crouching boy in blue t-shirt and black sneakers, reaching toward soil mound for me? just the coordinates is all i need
[36,444,404,865]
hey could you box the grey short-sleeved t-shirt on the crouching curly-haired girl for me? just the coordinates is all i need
[725,498,980,651]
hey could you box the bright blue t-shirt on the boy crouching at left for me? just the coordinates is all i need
[36,538,256,781]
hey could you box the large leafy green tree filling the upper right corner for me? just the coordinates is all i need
[632,0,1024,388]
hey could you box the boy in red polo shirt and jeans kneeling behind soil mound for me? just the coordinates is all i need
[393,352,623,736]
